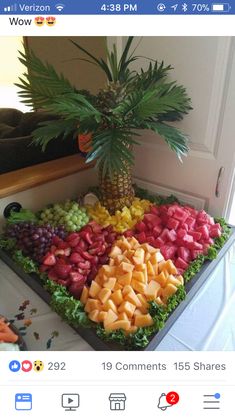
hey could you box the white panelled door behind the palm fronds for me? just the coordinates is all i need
[112,37,235,216]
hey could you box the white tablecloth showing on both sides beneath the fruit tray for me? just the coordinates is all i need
[0,245,235,351]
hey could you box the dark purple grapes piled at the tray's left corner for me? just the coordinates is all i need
[5,222,67,263]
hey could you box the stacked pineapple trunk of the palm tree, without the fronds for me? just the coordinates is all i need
[99,166,134,214]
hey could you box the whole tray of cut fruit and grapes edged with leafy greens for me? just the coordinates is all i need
[0,187,231,350]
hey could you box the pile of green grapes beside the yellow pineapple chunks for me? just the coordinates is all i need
[40,200,89,232]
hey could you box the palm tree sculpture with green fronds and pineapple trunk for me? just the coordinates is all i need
[17,37,191,213]
